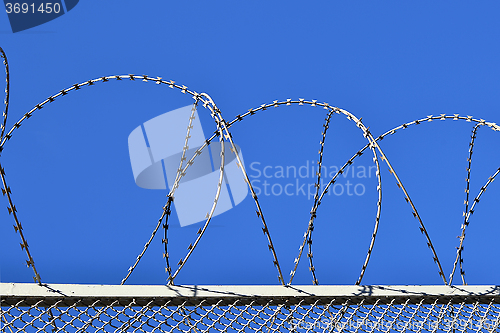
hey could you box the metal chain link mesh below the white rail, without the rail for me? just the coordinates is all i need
[1,287,500,332]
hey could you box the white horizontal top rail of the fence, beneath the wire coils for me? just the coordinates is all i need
[0,283,500,303]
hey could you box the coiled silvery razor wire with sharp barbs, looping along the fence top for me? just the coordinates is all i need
[0,48,500,285]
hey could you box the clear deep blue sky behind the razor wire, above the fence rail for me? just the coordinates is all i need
[0,0,500,284]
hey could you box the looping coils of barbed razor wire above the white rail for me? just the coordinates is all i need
[0,46,500,284]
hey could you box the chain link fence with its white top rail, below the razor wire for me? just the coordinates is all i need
[1,283,500,332]
